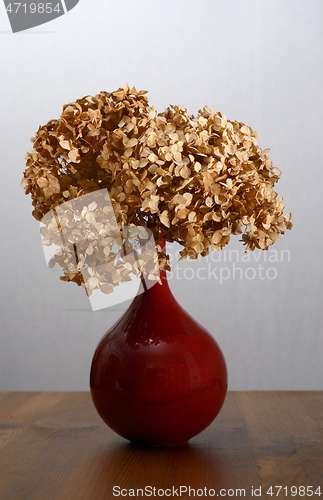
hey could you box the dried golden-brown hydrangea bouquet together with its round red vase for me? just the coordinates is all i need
[22,86,291,444]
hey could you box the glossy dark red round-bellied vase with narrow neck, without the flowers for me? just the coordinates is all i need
[90,266,227,445]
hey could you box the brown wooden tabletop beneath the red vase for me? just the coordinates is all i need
[0,392,323,500]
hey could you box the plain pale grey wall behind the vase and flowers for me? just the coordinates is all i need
[0,0,323,391]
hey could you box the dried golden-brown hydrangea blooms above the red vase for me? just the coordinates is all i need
[22,86,291,291]
